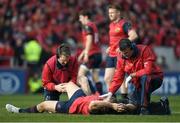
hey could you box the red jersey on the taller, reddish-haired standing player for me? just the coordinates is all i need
[109,19,128,57]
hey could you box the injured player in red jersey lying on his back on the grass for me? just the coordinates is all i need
[6,82,169,115]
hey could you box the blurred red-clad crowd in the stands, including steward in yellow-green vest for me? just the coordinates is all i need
[0,0,180,93]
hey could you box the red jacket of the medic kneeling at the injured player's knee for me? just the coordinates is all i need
[42,55,78,91]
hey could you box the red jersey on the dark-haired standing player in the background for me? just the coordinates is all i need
[82,22,101,56]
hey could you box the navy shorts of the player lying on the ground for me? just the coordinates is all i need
[56,89,86,113]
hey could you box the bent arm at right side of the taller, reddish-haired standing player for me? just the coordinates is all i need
[123,22,138,41]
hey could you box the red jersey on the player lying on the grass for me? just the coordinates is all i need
[69,94,100,115]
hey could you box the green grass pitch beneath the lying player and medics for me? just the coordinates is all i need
[0,95,180,122]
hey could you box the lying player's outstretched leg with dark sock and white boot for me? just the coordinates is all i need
[6,101,57,113]
